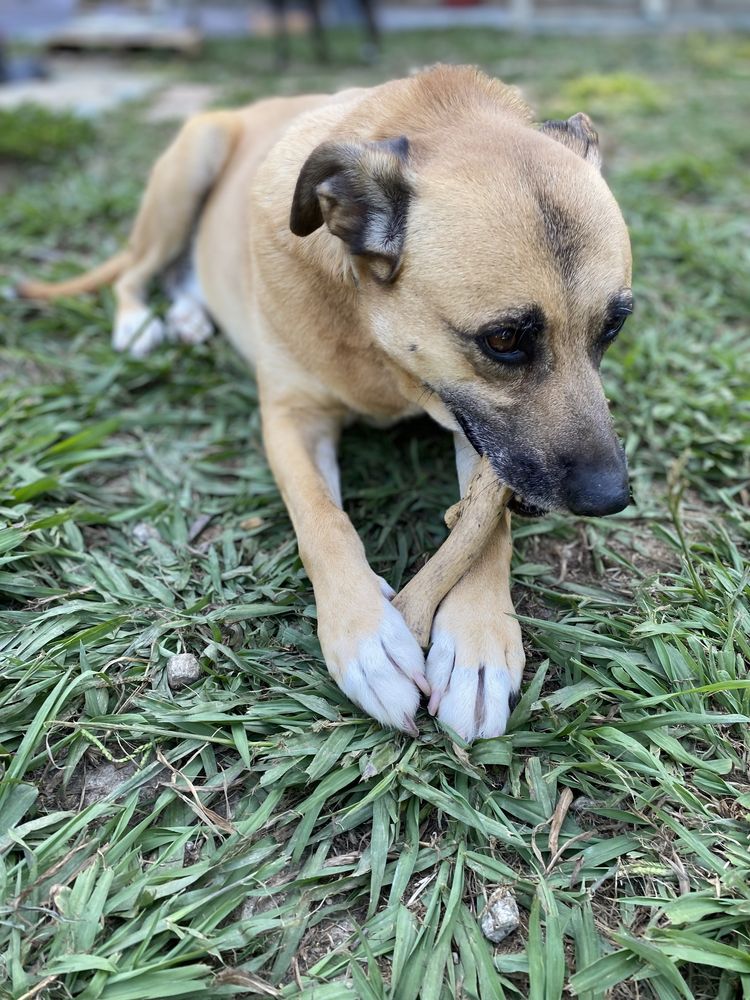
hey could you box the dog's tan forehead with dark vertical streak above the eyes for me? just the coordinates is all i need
[407,139,630,304]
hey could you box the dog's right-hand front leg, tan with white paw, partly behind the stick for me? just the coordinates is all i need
[427,433,525,740]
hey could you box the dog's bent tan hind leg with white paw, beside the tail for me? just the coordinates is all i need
[112,111,241,356]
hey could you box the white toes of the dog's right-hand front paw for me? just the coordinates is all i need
[427,630,524,742]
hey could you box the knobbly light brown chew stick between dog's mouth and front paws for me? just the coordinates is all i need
[393,457,513,649]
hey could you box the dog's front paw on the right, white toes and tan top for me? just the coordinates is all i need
[427,612,525,742]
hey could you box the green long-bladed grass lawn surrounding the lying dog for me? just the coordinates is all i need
[0,23,750,1000]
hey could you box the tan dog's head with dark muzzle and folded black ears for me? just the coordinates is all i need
[291,92,632,515]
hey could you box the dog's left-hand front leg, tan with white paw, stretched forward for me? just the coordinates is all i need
[261,385,429,735]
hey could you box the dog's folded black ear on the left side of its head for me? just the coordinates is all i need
[289,136,411,281]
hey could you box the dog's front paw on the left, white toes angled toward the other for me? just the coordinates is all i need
[319,578,430,736]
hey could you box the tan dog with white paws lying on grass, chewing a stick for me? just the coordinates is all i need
[21,60,631,739]
